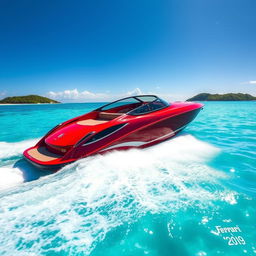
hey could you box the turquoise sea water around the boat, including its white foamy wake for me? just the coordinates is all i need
[0,102,256,256]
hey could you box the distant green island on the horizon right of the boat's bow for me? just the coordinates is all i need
[187,93,256,101]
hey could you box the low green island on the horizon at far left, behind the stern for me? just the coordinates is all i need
[0,95,60,104]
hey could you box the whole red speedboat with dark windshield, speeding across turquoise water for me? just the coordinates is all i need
[23,95,203,169]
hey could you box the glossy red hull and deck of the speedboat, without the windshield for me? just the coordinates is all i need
[23,100,203,170]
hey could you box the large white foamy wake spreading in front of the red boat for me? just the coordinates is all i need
[0,135,233,255]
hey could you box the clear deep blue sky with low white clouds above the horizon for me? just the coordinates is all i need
[0,0,256,102]
